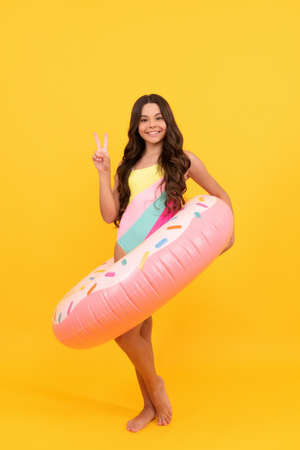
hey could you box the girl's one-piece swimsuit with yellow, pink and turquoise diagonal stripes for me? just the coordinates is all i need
[117,164,176,253]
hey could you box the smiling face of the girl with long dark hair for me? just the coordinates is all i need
[139,103,167,144]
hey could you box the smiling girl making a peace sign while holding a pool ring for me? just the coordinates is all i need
[92,94,234,431]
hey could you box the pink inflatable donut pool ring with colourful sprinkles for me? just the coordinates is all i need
[52,195,233,349]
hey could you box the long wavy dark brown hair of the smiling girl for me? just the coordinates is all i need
[114,94,191,228]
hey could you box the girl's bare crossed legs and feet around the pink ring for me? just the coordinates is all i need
[115,244,172,431]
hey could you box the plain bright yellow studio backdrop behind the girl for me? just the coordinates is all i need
[0,0,300,450]
